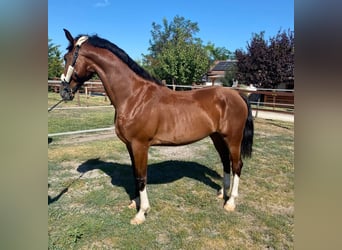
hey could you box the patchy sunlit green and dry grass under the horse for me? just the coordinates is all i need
[48,92,294,249]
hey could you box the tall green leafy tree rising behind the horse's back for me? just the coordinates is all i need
[143,16,209,85]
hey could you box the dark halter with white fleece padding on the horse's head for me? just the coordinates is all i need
[60,36,88,100]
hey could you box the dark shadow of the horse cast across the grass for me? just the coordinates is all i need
[77,158,222,199]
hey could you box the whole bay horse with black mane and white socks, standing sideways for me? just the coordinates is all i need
[60,29,254,224]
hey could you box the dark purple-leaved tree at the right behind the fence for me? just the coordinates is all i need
[235,31,294,88]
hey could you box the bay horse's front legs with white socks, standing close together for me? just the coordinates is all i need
[129,143,150,225]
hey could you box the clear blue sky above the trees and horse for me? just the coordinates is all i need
[48,0,294,60]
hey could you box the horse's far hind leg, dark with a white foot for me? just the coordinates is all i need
[210,133,231,200]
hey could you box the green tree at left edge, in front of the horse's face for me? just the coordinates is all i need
[48,38,63,79]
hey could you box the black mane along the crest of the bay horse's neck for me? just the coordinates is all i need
[67,35,162,85]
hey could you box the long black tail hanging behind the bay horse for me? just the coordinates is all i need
[241,95,254,157]
